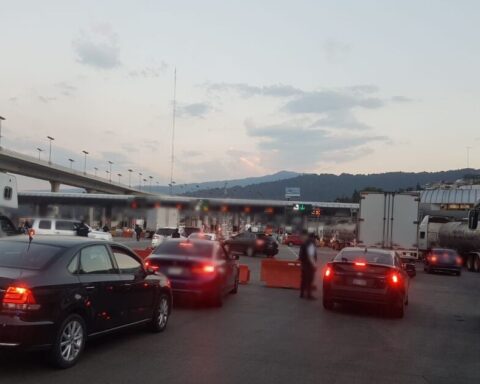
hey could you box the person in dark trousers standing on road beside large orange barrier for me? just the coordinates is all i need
[298,232,317,300]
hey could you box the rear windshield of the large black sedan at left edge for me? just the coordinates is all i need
[0,240,62,269]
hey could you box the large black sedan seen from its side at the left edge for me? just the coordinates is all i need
[0,236,172,368]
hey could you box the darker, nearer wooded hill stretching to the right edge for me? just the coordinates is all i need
[187,169,480,201]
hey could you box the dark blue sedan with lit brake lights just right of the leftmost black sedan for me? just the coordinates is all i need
[146,239,239,306]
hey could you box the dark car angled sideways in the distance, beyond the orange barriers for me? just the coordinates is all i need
[224,232,278,257]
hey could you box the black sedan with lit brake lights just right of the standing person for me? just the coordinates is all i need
[323,248,409,317]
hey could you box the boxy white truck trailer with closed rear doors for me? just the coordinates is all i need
[357,192,420,259]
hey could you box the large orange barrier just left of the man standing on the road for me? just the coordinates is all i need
[260,259,301,289]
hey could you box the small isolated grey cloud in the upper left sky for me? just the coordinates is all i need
[72,24,120,69]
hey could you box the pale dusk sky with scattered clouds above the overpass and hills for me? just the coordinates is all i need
[0,0,480,189]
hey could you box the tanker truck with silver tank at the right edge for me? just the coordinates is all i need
[419,202,480,272]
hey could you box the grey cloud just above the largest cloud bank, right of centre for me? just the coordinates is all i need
[282,90,385,113]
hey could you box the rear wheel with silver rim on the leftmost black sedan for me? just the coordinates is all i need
[50,314,87,369]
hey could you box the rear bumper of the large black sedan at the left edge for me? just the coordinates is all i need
[0,315,55,348]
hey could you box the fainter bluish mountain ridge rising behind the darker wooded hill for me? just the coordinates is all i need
[147,171,300,194]
